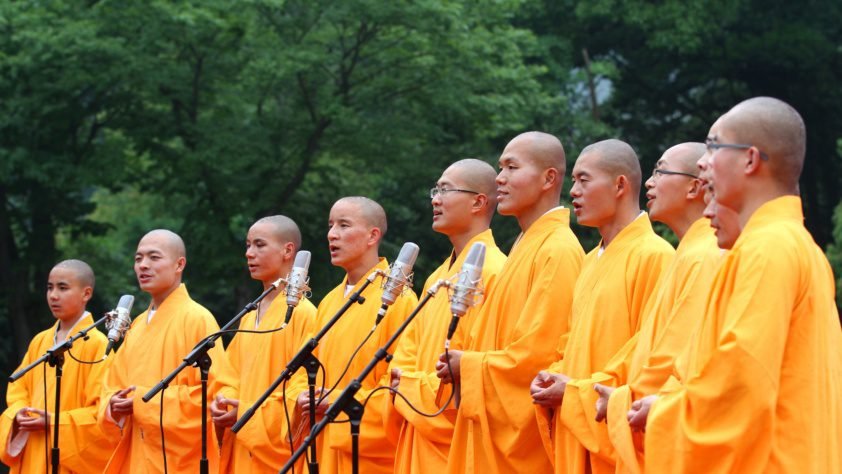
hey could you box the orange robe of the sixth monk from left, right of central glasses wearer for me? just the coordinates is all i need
[447,208,584,474]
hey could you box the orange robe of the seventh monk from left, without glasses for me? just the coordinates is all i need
[533,213,675,473]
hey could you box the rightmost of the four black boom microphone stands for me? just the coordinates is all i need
[280,280,449,474]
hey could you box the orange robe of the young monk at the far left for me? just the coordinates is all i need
[0,313,116,473]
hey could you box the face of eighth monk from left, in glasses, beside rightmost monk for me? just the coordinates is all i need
[646,148,698,224]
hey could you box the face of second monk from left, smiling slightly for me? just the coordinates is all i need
[134,233,186,296]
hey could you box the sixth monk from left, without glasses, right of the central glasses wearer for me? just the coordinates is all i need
[437,132,584,473]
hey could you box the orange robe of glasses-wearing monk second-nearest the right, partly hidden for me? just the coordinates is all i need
[608,218,722,473]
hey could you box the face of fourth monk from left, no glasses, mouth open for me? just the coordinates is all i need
[327,200,377,271]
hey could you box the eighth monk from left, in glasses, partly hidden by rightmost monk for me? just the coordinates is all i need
[563,143,720,472]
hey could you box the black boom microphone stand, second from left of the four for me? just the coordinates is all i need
[143,278,284,474]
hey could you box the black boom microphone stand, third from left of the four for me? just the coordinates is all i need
[231,270,384,474]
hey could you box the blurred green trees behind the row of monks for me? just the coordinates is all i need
[0,0,842,426]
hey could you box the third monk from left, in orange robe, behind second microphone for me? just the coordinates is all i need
[210,215,316,473]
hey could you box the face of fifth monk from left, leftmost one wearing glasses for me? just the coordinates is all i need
[430,167,478,235]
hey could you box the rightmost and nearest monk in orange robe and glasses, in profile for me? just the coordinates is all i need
[629,97,842,473]
